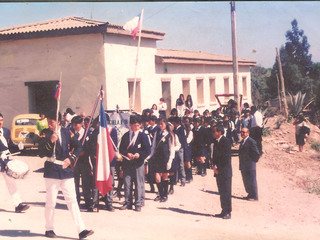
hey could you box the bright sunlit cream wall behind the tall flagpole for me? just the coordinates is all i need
[105,34,161,110]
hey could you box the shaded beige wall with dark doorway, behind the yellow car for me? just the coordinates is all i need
[0,34,105,127]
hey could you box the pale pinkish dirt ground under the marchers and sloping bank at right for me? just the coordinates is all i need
[0,118,320,240]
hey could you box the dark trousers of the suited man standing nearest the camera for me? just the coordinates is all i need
[216,174,232,213]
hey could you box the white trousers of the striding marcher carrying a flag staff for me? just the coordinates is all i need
[45,178,85,233]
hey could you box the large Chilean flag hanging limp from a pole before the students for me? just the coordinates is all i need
[96,100,114,196]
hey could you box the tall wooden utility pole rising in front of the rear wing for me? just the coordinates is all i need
[230,1,240,112]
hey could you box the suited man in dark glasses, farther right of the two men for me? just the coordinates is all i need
[239,128,260,201]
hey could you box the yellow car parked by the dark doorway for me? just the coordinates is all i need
[11,114,40,149]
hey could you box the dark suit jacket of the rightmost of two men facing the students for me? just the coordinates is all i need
[239,137,260,171]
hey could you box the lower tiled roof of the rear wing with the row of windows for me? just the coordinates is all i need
[156,49,257,66]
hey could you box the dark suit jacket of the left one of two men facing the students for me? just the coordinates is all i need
[213,136,232,178]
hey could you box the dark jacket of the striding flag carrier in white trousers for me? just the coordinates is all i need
[38,127,82,179]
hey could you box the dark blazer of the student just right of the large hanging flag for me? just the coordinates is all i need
[119,131,151,168]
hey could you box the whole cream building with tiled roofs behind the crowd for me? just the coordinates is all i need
[0,16,256,125]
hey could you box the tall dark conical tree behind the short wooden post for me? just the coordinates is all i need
[268,19,313,99]
